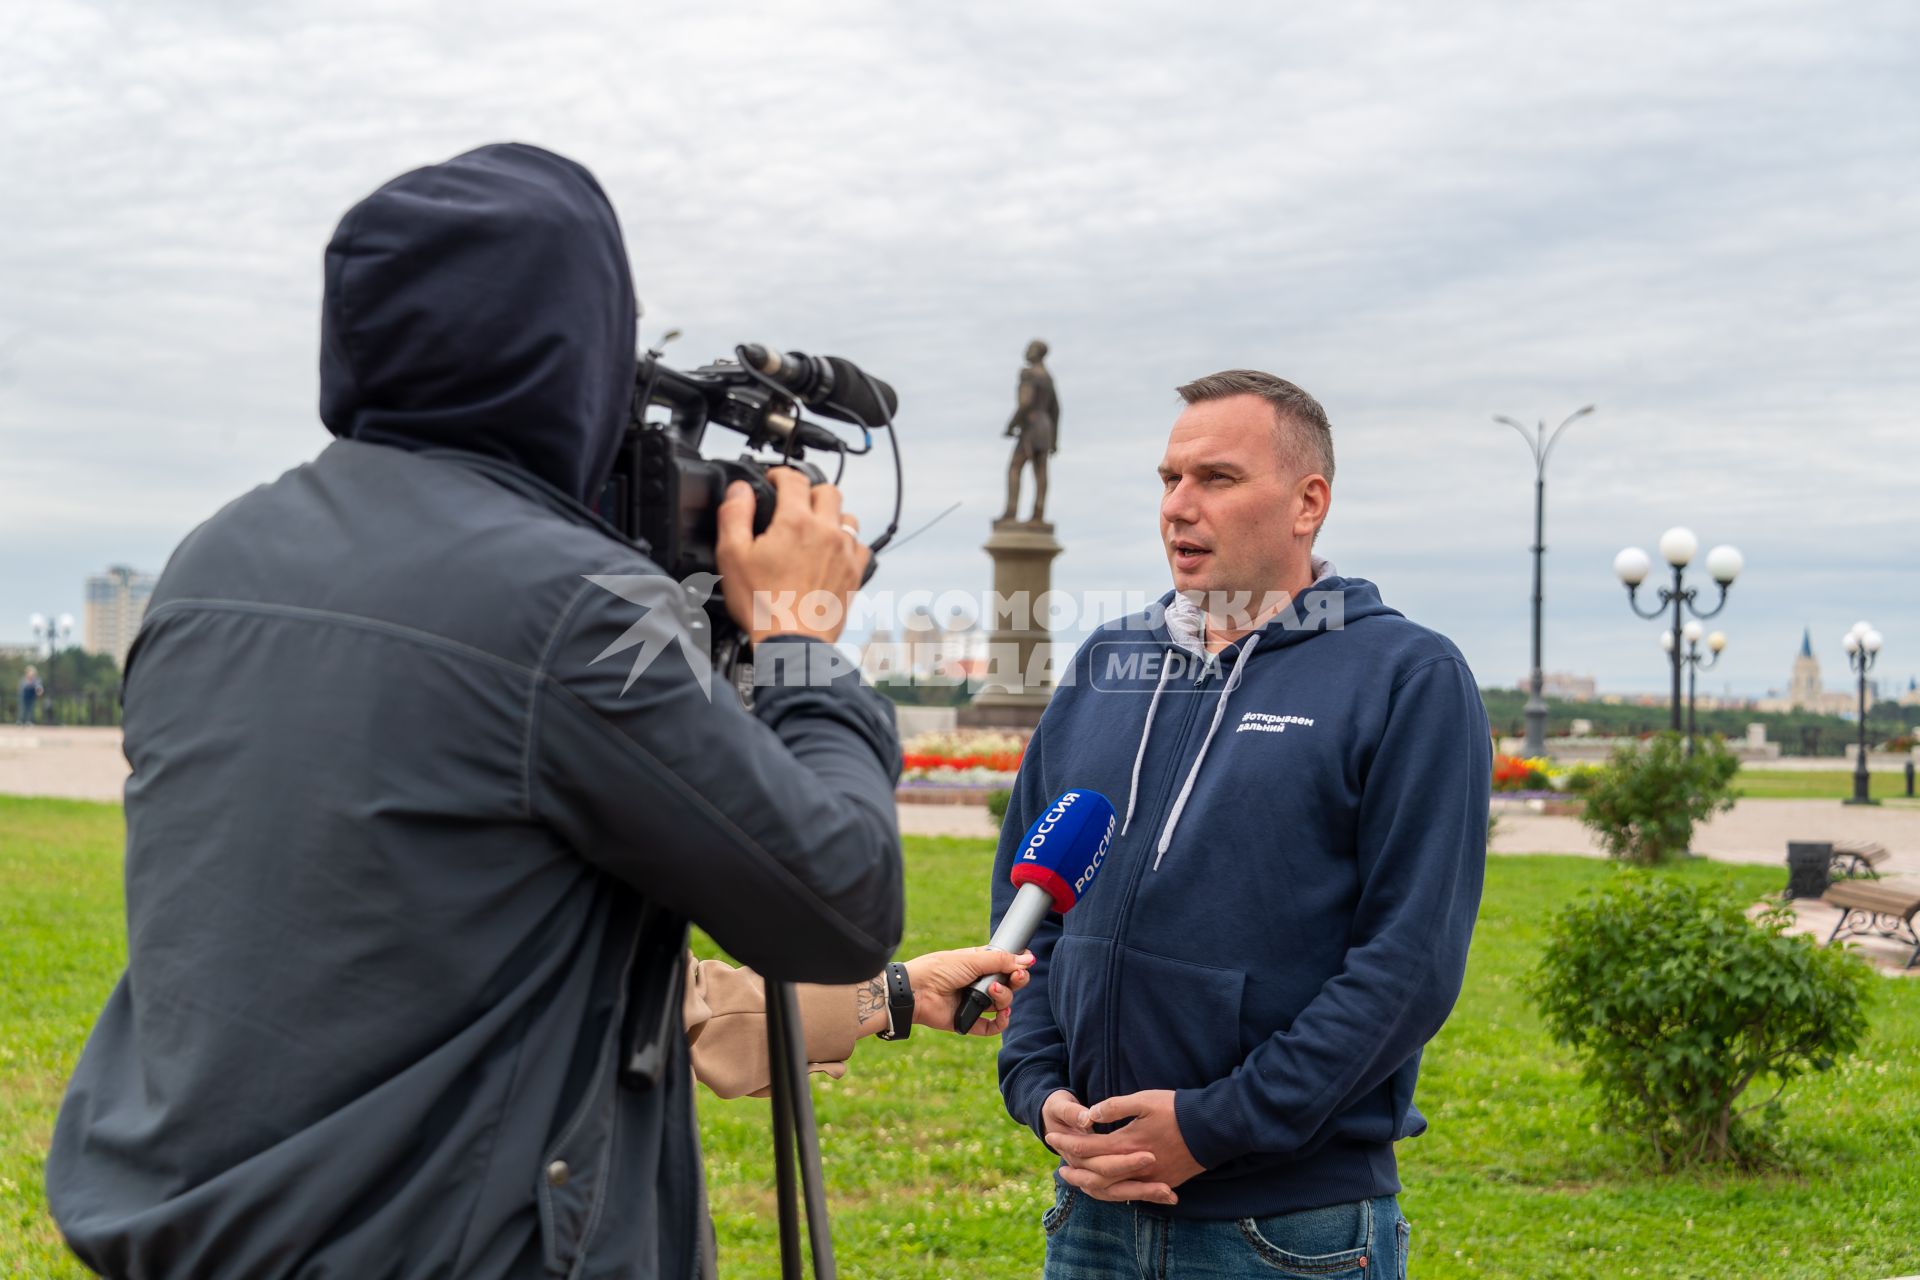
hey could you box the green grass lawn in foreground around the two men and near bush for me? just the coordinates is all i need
[0,798,1920,1280]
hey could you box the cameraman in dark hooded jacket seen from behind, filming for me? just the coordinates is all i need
[46,144,921,1280]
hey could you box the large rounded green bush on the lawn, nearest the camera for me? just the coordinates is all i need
[1528,875,1872,1165]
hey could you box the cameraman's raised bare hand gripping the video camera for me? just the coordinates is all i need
[714,466,872,643]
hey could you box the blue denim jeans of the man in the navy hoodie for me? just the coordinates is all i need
[1041,1178,1409,1280]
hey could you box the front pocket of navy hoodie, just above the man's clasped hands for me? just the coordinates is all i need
[1114,946,1246,1094]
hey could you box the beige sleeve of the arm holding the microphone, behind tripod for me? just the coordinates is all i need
[682,952,858,1098]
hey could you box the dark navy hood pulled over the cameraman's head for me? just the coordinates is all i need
[321,142,636,505]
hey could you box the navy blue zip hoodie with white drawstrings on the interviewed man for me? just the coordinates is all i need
[993,578,1492,1219]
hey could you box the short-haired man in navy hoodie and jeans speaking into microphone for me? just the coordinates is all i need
[993,370,1492,1280]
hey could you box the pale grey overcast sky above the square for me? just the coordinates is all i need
[0,0,1920,693]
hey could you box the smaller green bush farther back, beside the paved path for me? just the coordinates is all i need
[1580,733,1740,865]
